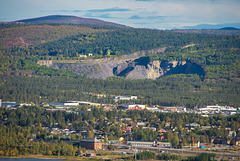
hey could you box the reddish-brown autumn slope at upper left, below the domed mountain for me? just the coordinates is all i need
[0,24,107,48]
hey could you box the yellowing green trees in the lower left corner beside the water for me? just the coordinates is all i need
[0,107,85,156]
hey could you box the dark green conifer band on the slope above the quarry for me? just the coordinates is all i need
[36,28,239,57]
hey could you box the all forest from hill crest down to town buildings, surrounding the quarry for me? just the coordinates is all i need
[0,20,240,107]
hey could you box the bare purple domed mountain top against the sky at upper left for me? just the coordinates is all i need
[15,15,127,27]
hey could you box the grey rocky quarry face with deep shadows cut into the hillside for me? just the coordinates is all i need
[38,57,205,79]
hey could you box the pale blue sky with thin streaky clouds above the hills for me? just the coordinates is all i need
[0,0,240,29]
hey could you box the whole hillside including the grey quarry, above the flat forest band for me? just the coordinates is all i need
[0,23,240,80]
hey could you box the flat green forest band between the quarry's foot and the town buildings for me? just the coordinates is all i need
[0,75,240,108]
